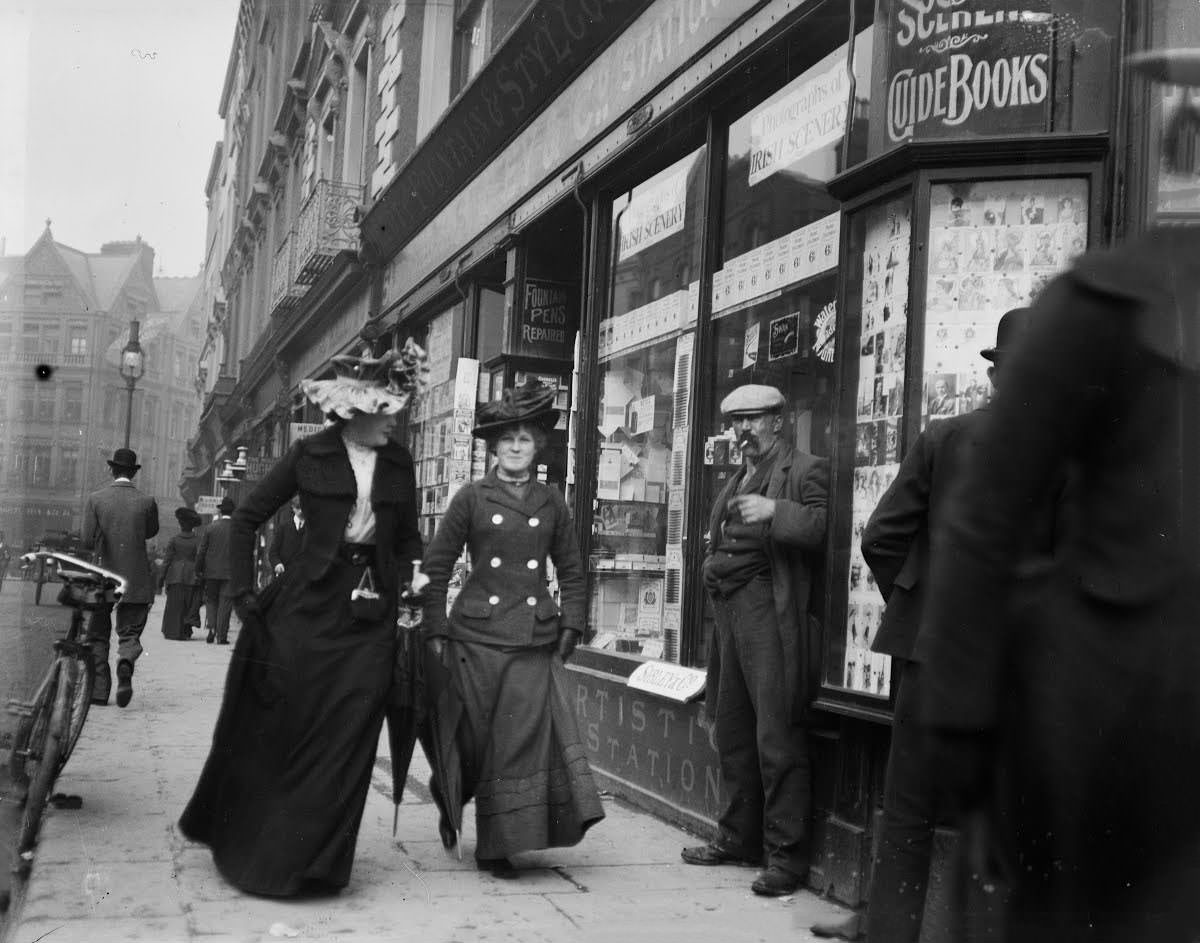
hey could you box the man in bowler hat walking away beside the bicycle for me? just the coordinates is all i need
[82,449,158,707]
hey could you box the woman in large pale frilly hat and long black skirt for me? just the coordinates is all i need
[180,342,426,896]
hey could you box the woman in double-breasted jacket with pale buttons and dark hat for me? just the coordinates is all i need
[422,379,604,877]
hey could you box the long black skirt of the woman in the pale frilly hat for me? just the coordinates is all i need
[180,563,395,896]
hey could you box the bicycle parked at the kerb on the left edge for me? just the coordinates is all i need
[8,551,125,872]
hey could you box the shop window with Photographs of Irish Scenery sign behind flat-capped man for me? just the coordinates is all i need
[696,40,854,660]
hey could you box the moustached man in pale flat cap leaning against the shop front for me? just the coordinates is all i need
[683,384,829,896]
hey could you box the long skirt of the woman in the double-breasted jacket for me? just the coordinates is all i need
[450,642,604,858]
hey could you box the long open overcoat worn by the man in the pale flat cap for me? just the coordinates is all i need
[704,442,829,717]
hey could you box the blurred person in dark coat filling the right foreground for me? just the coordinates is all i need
[922,49,1200,943]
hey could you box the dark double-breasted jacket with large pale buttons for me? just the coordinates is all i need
[422,470,586,648]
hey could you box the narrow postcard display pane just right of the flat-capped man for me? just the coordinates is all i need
[839,199,911,697]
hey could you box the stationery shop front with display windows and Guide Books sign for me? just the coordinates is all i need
[364,0,1181,903]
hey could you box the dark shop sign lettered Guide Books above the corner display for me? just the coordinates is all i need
[887,0,1051,143]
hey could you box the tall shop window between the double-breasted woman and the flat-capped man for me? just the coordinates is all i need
[584,149,706,662]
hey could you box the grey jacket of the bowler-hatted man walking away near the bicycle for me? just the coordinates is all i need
[80,481,158,605]
